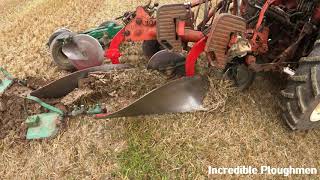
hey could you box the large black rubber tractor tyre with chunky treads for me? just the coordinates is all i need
[280,43,320,130]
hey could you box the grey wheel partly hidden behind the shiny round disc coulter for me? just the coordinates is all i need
[50,32,75,71]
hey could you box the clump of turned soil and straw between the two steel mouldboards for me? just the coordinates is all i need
[64,68,167,112]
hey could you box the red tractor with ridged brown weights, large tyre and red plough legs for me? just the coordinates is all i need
[101,0,320,130]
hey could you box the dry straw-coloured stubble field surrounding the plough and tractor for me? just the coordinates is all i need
[0,0,320,179]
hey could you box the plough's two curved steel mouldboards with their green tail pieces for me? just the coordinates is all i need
[0,64,207,140]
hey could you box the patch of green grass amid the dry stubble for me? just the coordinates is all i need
[118,120,167,179]
